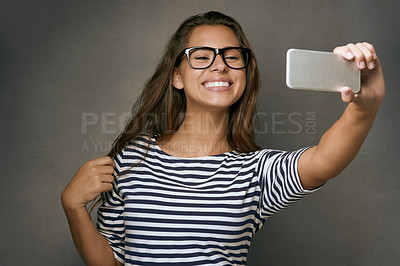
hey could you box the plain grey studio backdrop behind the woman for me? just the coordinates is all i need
[0,0,400,265]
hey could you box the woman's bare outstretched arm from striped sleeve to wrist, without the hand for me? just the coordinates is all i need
[299,103,378,188]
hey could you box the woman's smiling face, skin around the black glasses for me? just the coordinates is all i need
[173,25,246,112]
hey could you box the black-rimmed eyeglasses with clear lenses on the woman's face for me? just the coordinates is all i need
[177,47,251,69]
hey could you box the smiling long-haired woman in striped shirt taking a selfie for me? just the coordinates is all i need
[62,12,385,265]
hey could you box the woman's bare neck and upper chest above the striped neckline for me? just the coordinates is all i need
[159,111,232,157]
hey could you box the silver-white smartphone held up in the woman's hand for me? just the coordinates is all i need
[286,49,361,93]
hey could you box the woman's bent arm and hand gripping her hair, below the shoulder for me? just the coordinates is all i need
[61,156,120,265]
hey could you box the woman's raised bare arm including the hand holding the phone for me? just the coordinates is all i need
[298,42,385,189]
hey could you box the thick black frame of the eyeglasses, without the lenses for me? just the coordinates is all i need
[175,46,251,69]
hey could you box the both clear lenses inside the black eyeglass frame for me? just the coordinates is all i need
[189,48,247,68]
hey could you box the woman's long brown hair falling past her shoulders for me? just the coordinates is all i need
[108,11,259,160]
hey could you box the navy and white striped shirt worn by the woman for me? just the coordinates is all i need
[97,136,318,265]
